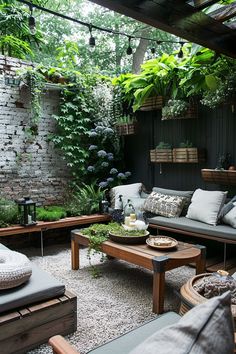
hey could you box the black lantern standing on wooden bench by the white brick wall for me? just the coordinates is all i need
[17,197,36,226]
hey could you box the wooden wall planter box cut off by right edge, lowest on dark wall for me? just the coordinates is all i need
[201,169,236,185]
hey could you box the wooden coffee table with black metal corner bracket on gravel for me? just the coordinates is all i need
[71,230,206,314]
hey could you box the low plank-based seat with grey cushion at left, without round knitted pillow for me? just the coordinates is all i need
[0,244,77,354]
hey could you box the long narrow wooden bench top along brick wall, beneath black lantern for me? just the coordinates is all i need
[0,214,110,237]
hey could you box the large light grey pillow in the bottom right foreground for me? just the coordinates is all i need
[130,292,234,354]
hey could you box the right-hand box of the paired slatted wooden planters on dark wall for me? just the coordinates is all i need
[173,148,205,163]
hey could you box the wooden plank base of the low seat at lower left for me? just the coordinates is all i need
[0,291,77,354]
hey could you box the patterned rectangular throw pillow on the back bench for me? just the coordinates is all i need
[143,192,185,218]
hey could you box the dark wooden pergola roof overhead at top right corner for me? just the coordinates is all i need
[91,0,236,58]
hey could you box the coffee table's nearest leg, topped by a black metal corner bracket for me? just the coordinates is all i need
[152,256,168,314]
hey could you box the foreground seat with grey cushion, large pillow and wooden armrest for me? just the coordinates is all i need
[49,292,234,354]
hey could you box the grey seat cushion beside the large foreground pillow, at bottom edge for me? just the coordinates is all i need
[89,312,180,354]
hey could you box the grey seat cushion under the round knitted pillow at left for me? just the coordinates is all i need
[0,244,65,313]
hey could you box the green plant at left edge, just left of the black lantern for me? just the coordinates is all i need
[0,198,19,227]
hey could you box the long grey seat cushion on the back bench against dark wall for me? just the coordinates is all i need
[148,216,236,241]
